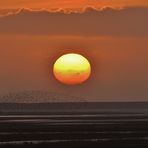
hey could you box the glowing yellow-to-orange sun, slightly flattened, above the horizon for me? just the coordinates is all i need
[53,53,91,85]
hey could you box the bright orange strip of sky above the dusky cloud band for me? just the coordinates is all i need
[0,0,148,9]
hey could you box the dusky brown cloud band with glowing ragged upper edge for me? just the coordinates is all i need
[0,7,148,37]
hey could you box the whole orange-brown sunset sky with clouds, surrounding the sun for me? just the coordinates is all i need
[0,0,148,101]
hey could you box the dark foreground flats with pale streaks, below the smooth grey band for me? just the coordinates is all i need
[0,102,148,148]
